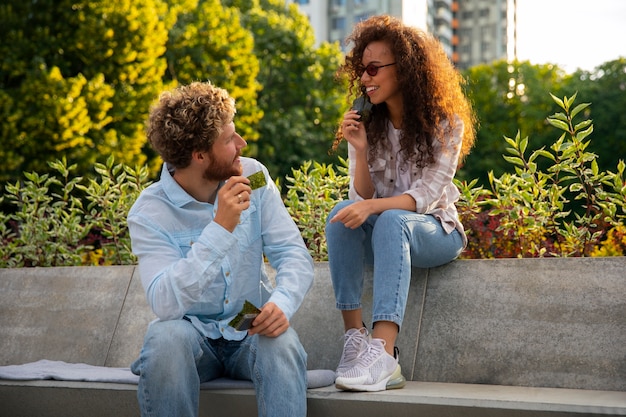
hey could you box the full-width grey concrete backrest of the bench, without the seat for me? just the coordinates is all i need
[0,257,626,391]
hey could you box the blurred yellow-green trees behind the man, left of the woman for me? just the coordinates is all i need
[0,0,347,187]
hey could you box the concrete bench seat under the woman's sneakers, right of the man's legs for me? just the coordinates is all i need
[309,382,626,417]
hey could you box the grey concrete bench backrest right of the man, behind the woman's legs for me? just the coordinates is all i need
[292,257,626,391]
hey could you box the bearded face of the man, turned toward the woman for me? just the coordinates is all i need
[203,122,247,181]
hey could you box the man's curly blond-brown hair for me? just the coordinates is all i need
[146,82,236,168]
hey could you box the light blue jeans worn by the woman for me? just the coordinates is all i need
[326,200,463,327]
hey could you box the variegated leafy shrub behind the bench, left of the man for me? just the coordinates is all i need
[0,157,148,267]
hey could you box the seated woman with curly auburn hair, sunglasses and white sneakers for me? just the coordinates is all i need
[326,16,475,391]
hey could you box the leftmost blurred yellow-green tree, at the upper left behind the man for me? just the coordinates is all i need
[0,0,168,181]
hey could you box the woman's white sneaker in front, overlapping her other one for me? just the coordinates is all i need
[335,339,404,391]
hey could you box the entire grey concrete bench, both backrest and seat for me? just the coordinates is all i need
[0,257,626,417]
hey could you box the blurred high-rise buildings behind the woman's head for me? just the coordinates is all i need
[288,0,516,69]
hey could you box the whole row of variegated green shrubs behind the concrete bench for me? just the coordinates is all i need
[0,95,626,267]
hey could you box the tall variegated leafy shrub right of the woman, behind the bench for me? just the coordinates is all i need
[457,95,626,258]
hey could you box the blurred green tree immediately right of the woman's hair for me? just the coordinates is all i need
[459,61,568,185]
